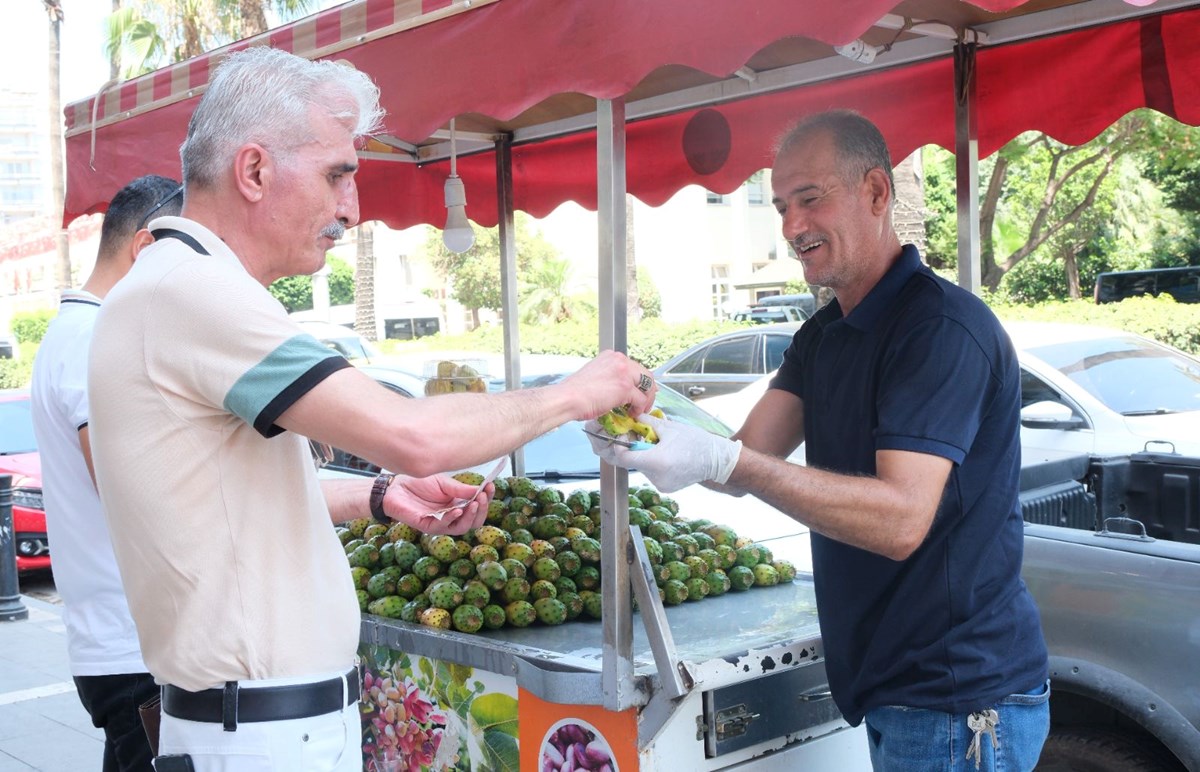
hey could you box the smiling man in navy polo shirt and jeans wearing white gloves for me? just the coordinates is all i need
[598,110,1049,771]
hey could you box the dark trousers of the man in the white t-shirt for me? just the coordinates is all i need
[74,672,158,772]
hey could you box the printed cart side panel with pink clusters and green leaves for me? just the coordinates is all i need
[360,647,521,772]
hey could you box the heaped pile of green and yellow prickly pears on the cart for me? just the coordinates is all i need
[337,473,796,633]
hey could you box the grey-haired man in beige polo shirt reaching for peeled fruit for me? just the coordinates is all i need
[89,47,654,772]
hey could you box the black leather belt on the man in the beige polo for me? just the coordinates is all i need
[162,668,359,731]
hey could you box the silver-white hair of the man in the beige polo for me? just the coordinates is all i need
[179,46,383,187]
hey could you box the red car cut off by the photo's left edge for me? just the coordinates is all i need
[0,389,50,571]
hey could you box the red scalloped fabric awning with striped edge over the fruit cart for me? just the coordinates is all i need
[65,0,1200,227]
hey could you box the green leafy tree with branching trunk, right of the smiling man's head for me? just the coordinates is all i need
[923,110,1200,301]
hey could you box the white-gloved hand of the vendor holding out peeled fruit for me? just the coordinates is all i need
[587,415,742,493]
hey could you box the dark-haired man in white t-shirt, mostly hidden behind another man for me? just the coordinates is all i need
[31,175,184,772]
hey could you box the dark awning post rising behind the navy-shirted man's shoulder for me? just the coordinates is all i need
[954,43,983,294]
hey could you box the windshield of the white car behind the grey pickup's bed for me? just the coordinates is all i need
[1027,336,1200,415]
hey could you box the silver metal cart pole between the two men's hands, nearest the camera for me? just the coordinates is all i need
[596,98,635,711]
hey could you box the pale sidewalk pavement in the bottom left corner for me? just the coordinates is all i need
[0,594,104,772]
